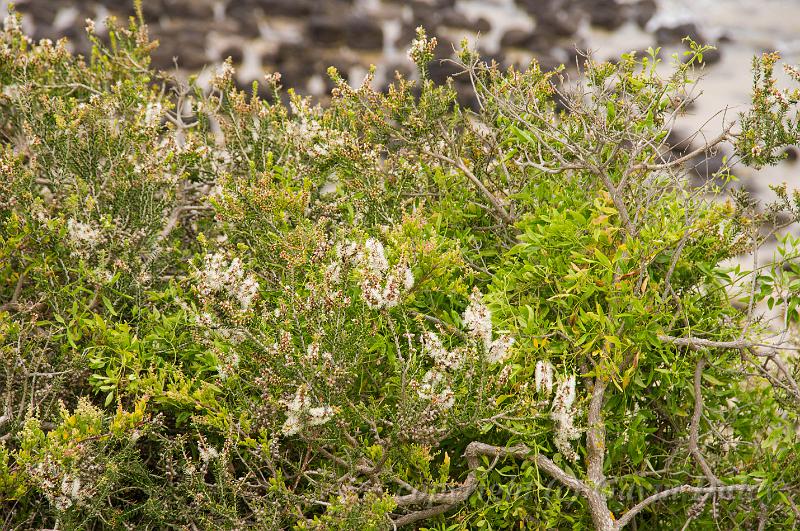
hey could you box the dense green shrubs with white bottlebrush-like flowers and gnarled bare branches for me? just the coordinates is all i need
[0,10,800,530]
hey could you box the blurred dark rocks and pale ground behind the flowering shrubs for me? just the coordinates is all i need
[0,0,800,214]
